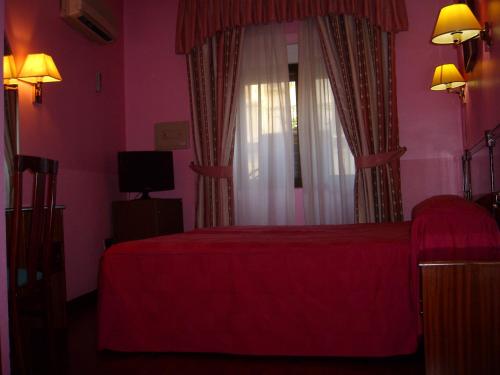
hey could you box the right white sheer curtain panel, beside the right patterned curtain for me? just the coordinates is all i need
[298,19,355,224]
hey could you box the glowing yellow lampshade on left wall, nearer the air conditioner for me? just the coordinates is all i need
[18,53,62,83]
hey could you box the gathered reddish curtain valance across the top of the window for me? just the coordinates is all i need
[175,0,408,54]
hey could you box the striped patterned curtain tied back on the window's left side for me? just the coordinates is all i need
[187,28,243,228]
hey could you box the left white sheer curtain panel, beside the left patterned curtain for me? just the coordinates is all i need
[233,24,295,225]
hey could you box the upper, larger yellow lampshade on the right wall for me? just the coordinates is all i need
[432,4,482,44]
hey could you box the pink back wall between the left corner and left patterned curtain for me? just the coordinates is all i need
[124,0,195,230]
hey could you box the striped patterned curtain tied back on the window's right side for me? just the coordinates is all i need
[317,15,406,223]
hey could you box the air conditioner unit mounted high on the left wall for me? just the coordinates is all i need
[61,0,116,43]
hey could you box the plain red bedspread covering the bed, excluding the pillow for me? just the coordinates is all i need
[99,223,418,356]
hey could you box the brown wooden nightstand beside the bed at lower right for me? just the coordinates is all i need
[420,262,500,375]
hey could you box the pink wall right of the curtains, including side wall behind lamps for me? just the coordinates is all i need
[397,0,500,214]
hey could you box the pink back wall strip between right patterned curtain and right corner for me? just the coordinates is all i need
[396,0,462,218]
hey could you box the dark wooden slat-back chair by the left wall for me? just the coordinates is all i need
[8,155,58,374]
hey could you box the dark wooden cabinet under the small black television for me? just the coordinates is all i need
[112,198,184,242]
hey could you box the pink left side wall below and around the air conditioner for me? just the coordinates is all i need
[6,0,125,299]
